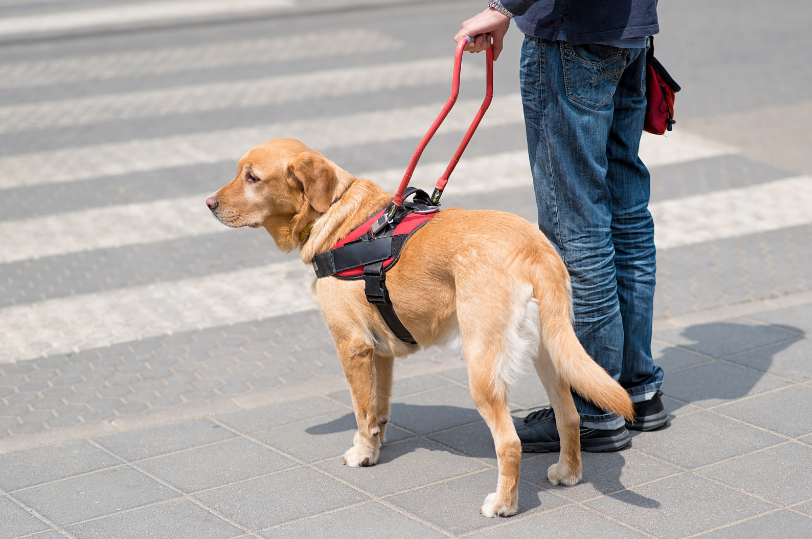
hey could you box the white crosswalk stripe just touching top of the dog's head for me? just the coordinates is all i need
[0,94,523,189]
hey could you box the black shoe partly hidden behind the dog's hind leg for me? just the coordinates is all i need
[514,408,631,453]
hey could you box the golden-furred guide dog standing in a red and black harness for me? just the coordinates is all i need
[206,139,633,517]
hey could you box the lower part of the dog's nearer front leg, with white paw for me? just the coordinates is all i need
[339,345,388,468]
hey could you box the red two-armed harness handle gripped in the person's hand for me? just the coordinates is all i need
[393,36,493,206]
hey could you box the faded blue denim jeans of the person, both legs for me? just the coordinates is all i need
[521,37,663,429]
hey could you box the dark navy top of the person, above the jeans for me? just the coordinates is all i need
[501,0,660,45]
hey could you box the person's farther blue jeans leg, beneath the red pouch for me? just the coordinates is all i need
[606,49,663,403]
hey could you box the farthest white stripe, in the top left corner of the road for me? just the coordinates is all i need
[0,0,295,37]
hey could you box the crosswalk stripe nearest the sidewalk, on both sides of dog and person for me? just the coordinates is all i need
[0,176,812,363]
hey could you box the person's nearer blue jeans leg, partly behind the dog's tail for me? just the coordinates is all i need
[521,38,629,429]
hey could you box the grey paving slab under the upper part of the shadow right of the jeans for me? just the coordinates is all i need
[656,319,797,358]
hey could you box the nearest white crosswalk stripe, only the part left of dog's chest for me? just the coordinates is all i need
[0,260,316,363]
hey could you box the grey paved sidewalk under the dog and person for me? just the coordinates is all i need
[0,293,812,539]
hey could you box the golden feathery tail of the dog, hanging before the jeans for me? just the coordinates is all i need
[533,270,634,421]
